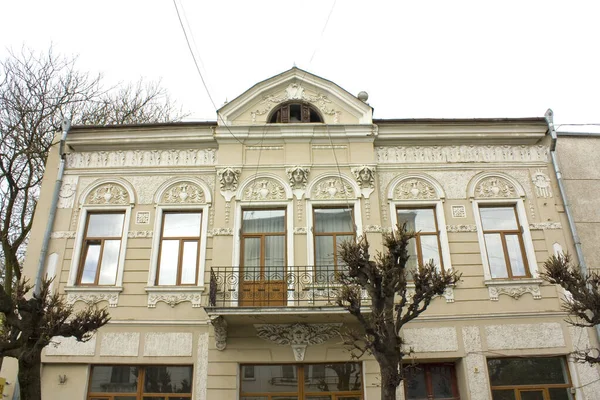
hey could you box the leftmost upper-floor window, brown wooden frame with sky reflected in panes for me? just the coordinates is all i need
[77,212,125,285]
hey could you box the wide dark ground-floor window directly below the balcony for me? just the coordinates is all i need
[240,363,363,400]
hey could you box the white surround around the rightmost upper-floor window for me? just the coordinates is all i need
[472,199,539,285]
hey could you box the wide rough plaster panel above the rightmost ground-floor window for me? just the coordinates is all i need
[485,322,565,350]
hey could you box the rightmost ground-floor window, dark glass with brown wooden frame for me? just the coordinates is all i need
[488,357,573,400]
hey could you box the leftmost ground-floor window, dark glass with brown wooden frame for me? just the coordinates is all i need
[87,365,192,400]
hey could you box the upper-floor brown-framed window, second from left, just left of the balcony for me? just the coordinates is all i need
[156,211,202,285]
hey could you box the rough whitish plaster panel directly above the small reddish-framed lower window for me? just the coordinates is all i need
[403,327,458,353]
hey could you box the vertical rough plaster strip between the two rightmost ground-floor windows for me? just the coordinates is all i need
[462,326,490,400]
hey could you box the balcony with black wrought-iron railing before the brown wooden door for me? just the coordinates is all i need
[206,265,368,322]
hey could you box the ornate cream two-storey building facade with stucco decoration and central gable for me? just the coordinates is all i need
[17,68,600,400]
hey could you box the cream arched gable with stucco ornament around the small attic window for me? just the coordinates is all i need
[218,67,373,125]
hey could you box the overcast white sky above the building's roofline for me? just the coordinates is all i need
[0,0,600,130]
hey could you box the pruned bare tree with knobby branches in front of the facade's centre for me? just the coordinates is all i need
[337,226,461,400]
